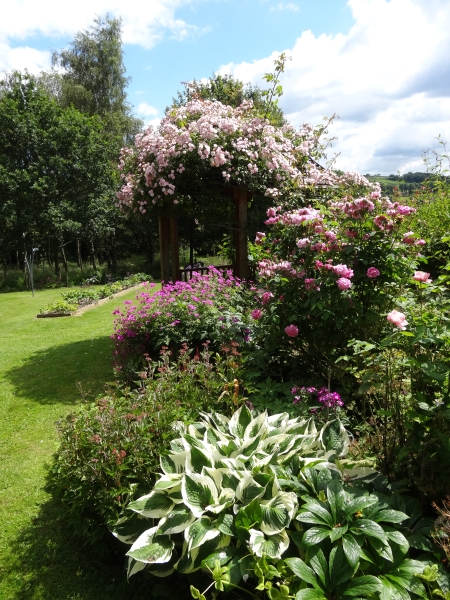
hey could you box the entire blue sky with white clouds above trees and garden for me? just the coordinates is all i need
[0,0,450,175]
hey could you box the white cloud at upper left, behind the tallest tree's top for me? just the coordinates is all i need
[0,0,203,72]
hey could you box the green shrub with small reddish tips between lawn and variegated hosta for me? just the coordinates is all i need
[47,346,238,552]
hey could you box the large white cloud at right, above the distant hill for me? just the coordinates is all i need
[220,0,450,173]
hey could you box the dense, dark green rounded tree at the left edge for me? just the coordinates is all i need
[0,73,118,270]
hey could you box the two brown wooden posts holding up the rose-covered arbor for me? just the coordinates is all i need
[159,186,252,282]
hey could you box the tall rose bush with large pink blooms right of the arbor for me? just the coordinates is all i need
[250,190,423,381]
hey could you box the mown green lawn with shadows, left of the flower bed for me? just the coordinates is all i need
[0,290,162,600]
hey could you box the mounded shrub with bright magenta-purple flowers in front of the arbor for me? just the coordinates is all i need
[112,267,252,375]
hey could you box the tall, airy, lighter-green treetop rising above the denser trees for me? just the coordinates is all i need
[52,15,142,149]
